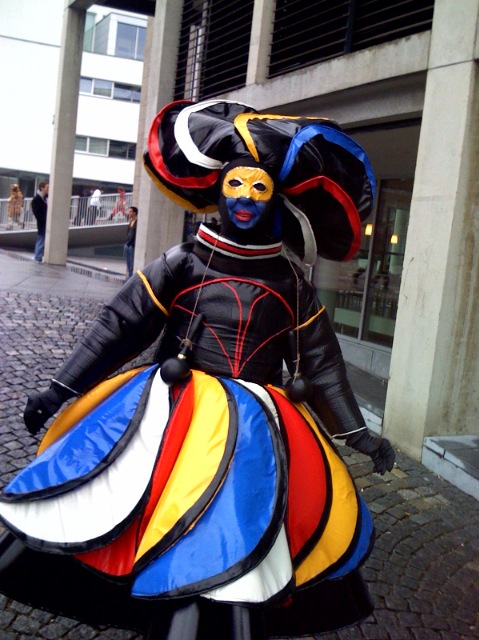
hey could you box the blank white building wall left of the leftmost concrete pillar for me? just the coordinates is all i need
[0,0,63,174]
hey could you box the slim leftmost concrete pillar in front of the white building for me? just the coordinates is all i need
[44,7,85,265]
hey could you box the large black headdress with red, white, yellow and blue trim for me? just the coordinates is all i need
[144,100,376,264]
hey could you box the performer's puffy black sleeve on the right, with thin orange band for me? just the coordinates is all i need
[297,281,365,434]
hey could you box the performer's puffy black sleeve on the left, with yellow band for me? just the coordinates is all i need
[55,256,179,393]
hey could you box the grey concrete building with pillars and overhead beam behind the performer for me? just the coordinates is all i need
[28,0,479,459]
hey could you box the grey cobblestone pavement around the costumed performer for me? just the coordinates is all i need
[0,259,479,640]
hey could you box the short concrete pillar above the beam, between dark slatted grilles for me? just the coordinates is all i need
[246,0,275,85]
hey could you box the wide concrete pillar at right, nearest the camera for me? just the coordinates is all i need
[384,0,479,459]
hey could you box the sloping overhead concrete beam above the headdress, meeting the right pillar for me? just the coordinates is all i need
[222,31,430,124]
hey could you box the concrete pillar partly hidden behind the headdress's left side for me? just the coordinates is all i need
[135,0,184,268]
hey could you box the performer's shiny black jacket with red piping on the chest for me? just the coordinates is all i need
[55,228,364,433]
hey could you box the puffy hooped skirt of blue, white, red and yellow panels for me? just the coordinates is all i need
[0,365,374,638]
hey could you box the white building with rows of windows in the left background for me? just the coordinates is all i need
[0,0,146,198]
